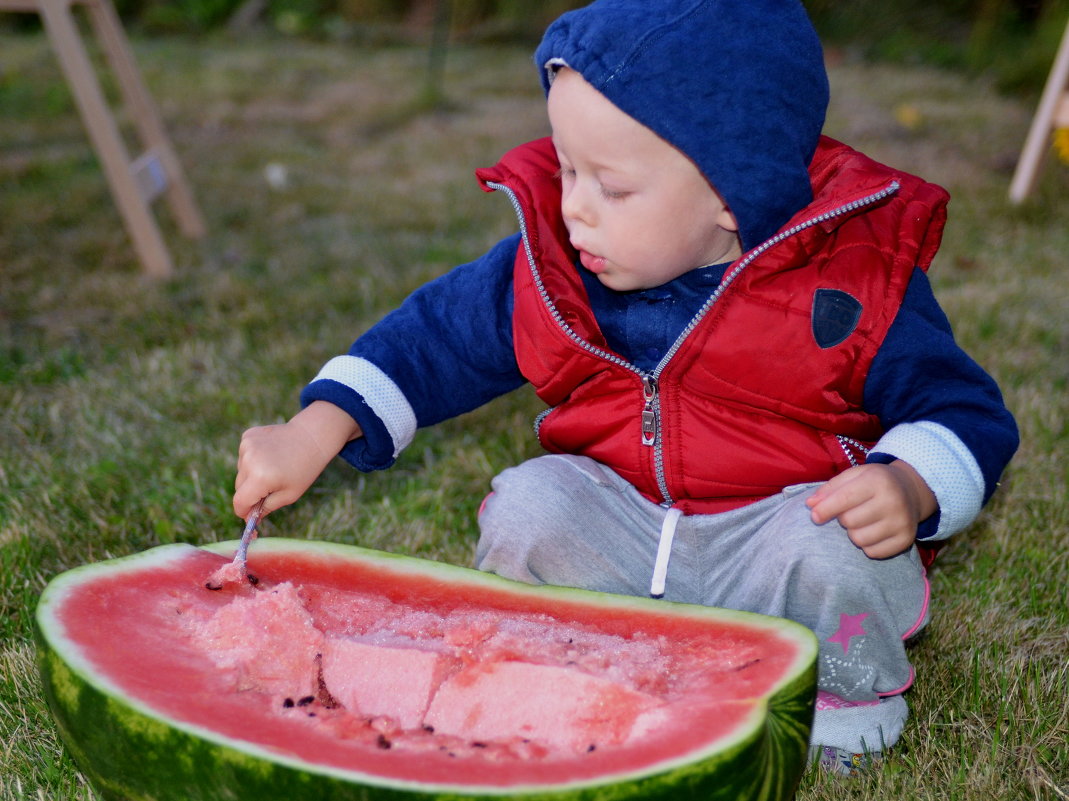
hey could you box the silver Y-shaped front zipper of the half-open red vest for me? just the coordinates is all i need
[486,180,900,508]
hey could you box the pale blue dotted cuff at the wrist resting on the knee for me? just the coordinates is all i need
[872,420,985,540]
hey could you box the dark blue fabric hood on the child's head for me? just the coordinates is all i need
[535,0,828,250]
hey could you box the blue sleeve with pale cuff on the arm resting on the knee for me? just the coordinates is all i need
[865,269,1018,538]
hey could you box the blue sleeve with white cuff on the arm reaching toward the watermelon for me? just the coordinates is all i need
[300,234,524,471]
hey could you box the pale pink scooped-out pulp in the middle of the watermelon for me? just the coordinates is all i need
[191,582,679,753]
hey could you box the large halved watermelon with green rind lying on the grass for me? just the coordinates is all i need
[37,539,816,799]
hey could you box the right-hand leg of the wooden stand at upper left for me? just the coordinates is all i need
[82,0,205,238]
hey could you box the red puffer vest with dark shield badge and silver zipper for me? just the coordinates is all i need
[477,138,947,513]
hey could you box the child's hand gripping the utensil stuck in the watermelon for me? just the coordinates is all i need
[234,401,361,518]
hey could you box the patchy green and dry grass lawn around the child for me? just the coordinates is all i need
[0,29,1069,801]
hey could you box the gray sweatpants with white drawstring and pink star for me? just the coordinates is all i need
[476,456,928,752]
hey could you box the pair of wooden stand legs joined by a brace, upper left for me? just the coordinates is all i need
[0,0,205,277]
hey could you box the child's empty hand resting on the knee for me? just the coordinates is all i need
[806,460,938,559]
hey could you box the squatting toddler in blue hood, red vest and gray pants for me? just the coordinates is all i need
[234,0,1017,771]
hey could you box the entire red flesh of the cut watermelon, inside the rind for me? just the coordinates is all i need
[50,541,797,786]
